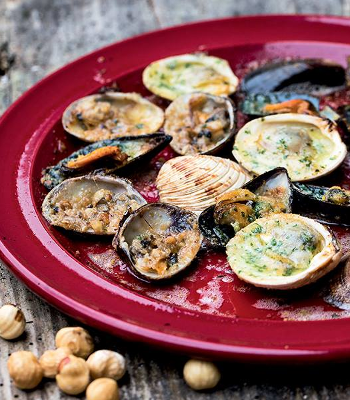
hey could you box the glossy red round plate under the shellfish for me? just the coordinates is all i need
[0,16,350,362]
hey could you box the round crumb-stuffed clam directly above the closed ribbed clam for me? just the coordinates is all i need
[164,92,235,155]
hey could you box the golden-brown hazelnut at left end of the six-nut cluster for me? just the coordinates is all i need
[7,351,43,389]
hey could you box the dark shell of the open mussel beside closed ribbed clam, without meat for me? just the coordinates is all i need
[198,168,293,248]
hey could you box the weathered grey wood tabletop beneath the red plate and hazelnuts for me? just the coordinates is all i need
[0,0,350,400]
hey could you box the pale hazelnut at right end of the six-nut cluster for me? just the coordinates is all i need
[86,350,125,381]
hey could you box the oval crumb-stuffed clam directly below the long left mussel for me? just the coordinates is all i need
[42,174,146,235]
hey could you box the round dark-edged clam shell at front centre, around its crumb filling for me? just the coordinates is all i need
[112,203,202,281]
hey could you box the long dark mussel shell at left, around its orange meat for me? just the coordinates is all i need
[41,133,172,190]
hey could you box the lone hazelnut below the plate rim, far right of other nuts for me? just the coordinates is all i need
[183,360,221,390]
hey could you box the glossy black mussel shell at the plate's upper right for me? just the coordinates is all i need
[241,59,346,96]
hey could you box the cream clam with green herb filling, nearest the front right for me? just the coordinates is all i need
[226,214,341,289]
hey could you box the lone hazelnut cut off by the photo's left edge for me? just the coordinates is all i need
[0,304,26,339]
